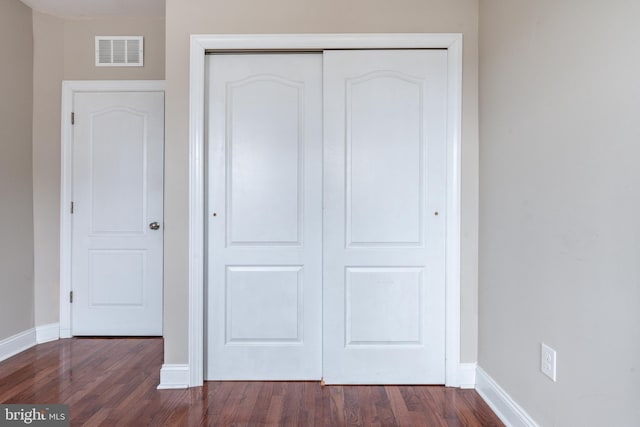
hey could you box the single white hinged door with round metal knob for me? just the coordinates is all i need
[71,92,164,335]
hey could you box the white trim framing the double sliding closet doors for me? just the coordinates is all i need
[188,34,462,387]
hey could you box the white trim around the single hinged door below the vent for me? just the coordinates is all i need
[60,80,165,338]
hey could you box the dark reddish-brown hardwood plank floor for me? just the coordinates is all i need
[0,338,503,426]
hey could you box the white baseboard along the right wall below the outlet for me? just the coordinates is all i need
[476,367,538,427]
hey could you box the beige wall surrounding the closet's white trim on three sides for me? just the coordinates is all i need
[164,0,478,363]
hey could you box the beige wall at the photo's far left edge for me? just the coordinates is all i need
[0,0,34,340]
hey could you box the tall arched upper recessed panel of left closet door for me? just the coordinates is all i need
[226,75,305,246]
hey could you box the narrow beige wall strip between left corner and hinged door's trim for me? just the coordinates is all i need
[33,12,64,326]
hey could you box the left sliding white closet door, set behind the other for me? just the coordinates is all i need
[206,54,322,380]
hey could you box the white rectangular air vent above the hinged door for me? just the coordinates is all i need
[96,36,144,67]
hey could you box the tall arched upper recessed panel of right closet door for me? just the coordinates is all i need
[345,71,425,246]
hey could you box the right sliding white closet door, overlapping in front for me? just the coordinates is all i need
[323,50,447,384]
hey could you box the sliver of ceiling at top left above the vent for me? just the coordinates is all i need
[22,0,165,18]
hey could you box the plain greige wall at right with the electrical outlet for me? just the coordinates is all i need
[479,0,640,426]
